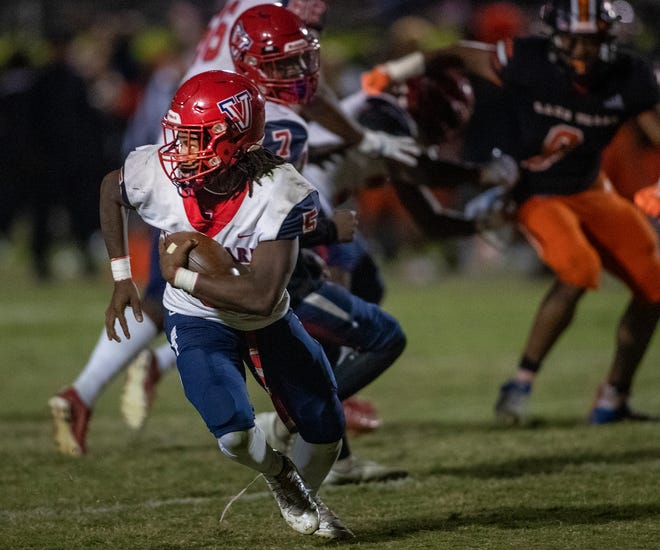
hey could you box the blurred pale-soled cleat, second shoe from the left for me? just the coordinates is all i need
[120,349,160,430]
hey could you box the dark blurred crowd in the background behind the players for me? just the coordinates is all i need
[0,0,660,281]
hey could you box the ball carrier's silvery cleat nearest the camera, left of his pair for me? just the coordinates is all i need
[264,456,320,535]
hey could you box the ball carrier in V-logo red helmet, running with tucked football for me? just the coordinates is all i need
[100,71,352,538]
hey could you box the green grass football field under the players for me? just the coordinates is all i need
[0,256,660,550]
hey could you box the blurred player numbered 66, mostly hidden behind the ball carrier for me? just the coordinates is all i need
[49,0,417,462]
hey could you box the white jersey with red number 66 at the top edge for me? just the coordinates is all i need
[182,0,275,82]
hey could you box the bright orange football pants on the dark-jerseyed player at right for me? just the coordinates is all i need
[517,177,660,302]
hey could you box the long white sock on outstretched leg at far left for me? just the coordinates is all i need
[73,309,158,407]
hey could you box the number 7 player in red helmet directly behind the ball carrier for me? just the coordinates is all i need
[118,4,407,484]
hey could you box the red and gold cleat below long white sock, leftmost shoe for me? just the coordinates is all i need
[48,388,92,457]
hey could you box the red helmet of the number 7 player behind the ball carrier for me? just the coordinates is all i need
[229,4,320,105]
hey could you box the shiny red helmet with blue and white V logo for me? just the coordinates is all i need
[158,71,266,196]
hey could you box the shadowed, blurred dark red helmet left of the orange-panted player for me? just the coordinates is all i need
[407,65,474,145]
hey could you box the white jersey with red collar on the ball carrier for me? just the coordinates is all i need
[122,145,318,330]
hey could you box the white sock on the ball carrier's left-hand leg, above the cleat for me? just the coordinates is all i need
[218,426,282,476]
